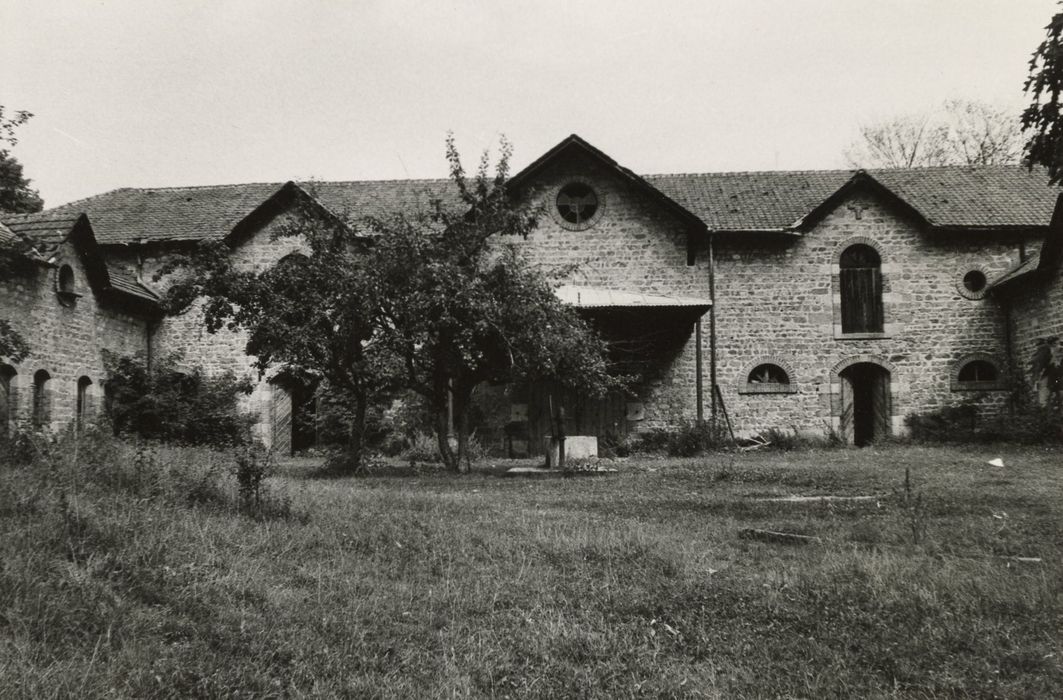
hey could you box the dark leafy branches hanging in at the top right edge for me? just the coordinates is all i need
[1023,13,1063,184]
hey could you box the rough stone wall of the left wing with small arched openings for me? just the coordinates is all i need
[0,242,148,430]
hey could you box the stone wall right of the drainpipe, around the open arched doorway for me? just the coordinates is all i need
[715,194,1018,433]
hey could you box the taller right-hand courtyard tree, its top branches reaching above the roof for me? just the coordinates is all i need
[366,137,621,471]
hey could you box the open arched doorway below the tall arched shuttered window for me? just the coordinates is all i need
[838,362,893,447]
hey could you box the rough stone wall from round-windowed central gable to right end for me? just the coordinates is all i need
[512,152,1031,434]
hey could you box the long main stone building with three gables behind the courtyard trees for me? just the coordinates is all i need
[0,136,1063,448]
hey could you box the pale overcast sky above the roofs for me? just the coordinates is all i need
[0,0,1057,206]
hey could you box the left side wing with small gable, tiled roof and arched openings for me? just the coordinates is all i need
[0,212,162,434]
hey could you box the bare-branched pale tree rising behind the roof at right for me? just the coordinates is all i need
[846,100,1023,168]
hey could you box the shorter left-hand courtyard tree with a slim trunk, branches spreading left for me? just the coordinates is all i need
[158,197,395,471]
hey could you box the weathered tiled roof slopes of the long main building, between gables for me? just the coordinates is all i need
[41,166,1058,244]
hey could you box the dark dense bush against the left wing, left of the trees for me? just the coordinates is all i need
[104,352,254,446]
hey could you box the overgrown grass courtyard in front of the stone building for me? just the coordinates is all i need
[0,446,1063,698]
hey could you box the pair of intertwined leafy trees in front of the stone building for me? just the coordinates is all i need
[162,139,620,471]
